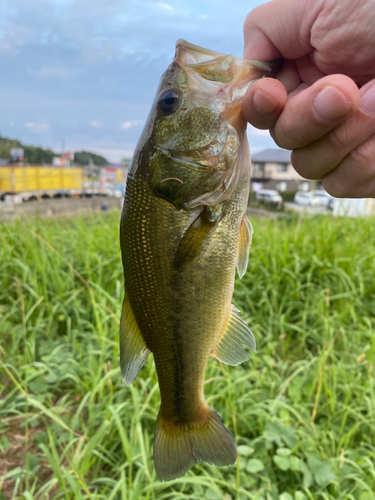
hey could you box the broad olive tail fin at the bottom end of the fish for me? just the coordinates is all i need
[154,406,237,481]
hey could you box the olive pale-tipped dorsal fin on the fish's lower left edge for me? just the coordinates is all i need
[120,293,150,385]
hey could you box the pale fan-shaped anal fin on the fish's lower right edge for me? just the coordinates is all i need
[212,305,256,366]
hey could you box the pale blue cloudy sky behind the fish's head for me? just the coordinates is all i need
[0,0,274,161]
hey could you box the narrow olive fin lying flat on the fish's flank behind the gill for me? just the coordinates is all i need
[174,209,221,269]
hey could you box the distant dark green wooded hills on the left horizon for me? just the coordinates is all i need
[0,135,109,165]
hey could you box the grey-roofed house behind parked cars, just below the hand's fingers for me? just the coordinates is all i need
[251,149,318,192]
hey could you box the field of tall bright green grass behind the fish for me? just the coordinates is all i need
[0,213,375,500]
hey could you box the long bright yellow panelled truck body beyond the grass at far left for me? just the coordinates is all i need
[0,166,83,201]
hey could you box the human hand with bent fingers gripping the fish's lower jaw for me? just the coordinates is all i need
[242,0,375,197]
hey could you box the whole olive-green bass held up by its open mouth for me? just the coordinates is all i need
[120,40,272,481]
